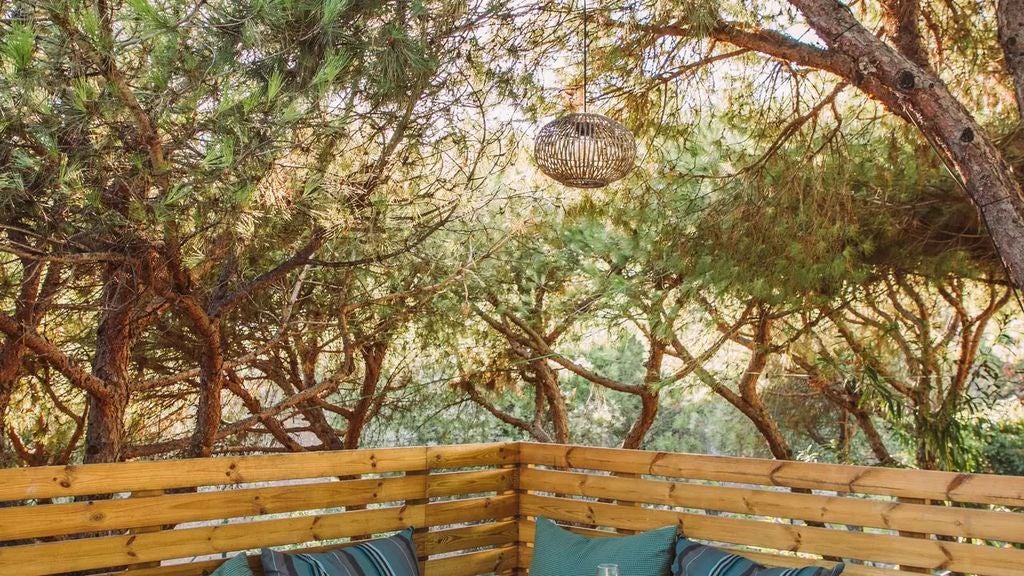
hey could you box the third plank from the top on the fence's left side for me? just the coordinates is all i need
[0,496,515,575]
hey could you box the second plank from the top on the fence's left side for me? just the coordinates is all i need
[0,463,513,540]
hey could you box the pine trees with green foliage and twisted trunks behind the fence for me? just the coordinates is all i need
[0,0,1024,474]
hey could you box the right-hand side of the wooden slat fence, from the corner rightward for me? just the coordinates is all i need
[519,444,1024,576]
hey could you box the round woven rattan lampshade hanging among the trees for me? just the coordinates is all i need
[534,113,637,188]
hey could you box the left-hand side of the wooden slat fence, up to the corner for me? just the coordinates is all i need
[0,444,518,576]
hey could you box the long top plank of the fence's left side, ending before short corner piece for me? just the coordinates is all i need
[0,448,426,500]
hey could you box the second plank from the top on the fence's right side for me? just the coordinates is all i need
[520,468,1024,542]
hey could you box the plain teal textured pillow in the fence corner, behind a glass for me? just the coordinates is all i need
[529,518,676,576]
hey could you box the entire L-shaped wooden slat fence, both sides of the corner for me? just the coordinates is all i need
[0,443,1024,576]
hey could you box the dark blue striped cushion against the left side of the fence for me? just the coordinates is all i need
[260,528,420,576]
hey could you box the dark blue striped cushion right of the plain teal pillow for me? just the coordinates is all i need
[672,538,846,576]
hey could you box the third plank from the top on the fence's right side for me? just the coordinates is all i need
[521,495,1024,576]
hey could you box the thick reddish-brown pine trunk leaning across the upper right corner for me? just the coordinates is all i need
[645,0,1024,287]
